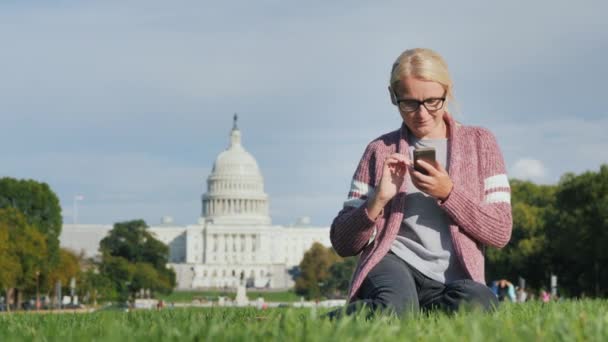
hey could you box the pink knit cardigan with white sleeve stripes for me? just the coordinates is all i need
[330,113,512,300]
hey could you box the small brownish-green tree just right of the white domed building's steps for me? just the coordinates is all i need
[295,242,341,298]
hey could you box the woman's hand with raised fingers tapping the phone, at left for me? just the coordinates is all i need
[367,153,411,218]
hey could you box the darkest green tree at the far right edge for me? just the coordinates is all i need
[549,165,608,297]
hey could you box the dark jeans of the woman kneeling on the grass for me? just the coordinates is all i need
[328,252,498,318]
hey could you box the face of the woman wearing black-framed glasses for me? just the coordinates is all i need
[394,77,446,139]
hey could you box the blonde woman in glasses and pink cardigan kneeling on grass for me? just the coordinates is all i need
[330,49,512,315]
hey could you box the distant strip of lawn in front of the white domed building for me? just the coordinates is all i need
[159,290,300,303]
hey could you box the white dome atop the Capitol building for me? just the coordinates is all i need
[202,116,271,224]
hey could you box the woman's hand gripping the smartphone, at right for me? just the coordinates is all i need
[410,160,454,201]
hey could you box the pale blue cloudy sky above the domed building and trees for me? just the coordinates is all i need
[0,0,608,226]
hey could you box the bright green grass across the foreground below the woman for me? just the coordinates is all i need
[0,300,608,342]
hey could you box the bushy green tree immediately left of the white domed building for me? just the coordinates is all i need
[99,220,175,300]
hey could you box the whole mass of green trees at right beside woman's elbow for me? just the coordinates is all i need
[486,165,608,297]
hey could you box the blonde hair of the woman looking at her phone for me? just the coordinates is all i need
[390,48,454,103]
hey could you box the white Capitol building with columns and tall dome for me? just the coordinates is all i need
[60,115,330,289]
